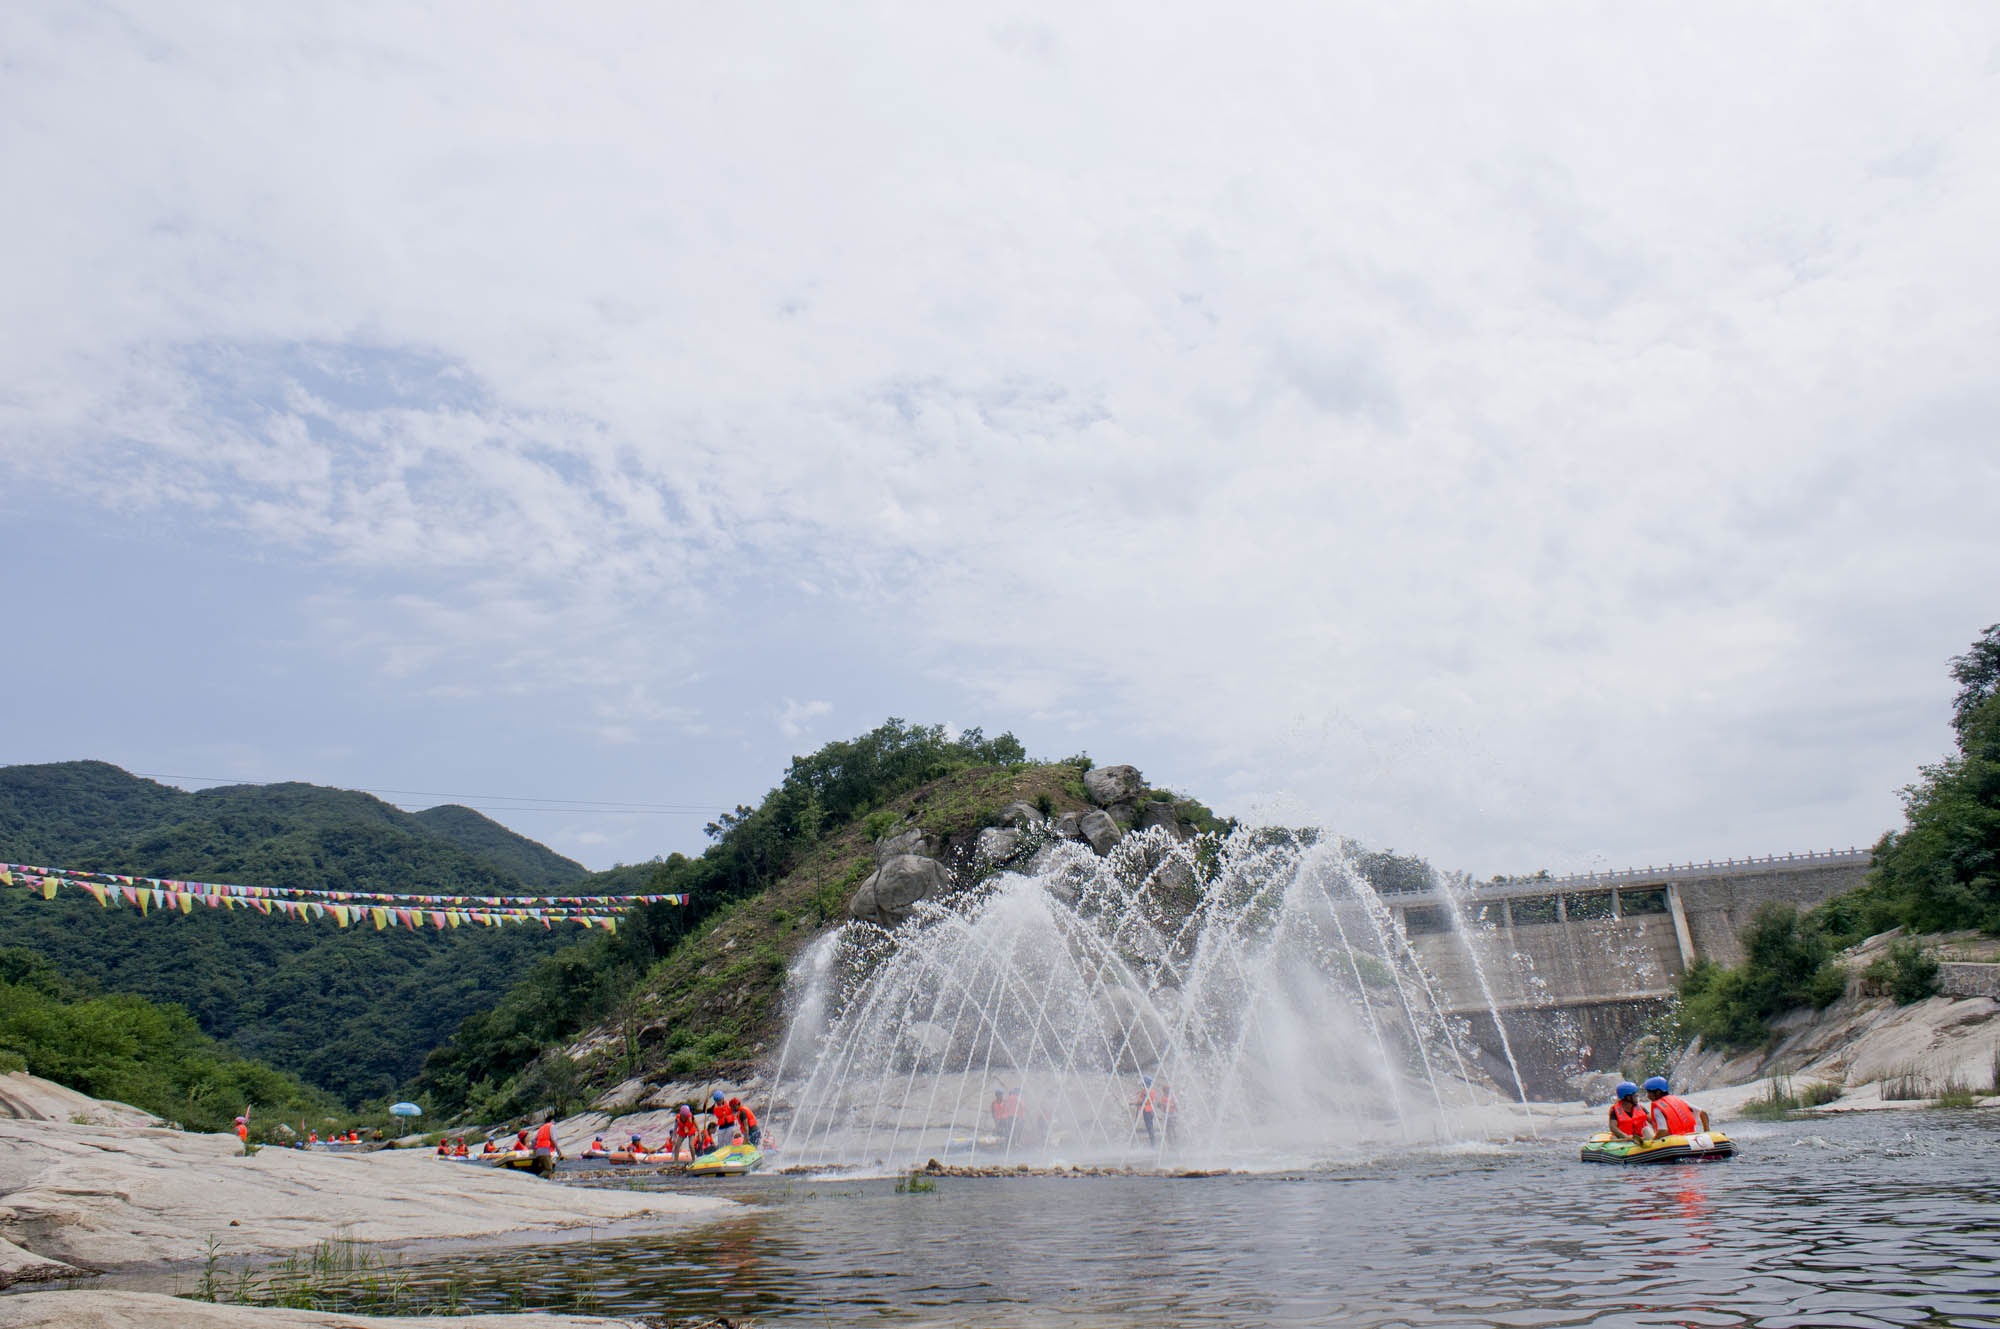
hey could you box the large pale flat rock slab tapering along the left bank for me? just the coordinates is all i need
[0,1121,736,1271]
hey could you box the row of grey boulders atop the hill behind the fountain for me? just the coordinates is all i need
[848,767,1194,927]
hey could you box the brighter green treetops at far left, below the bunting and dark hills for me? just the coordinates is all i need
[0,947,334,1131]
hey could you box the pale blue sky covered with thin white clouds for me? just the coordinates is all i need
[0,0,2000,877]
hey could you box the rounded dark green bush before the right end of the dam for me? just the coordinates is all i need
[1680,903,1846,1047]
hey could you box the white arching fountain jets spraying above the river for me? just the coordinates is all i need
[774,829,1520,1167]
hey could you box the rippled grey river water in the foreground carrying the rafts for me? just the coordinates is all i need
[308,1111,2000,1327]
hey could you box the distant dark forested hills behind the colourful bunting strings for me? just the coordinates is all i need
[0,761,590,1103]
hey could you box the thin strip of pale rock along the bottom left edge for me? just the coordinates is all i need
[0,1291,638,1329]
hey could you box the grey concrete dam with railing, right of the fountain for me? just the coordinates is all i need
[1384,849,1874,1095]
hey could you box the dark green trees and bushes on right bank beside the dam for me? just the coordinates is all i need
[1680,622,2000,1048]
